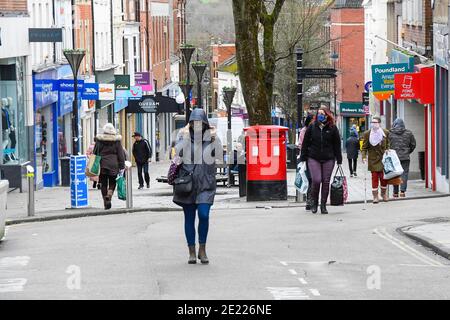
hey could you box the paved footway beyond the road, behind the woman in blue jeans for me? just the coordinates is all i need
[6,155,448,225]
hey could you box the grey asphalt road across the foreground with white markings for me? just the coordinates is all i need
[0,198,450,303]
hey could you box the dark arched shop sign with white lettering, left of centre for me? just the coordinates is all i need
[126,95,181,113]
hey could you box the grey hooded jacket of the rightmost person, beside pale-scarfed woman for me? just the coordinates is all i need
[389,118,416,160]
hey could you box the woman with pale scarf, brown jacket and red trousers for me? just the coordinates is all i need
[362,117,389,204]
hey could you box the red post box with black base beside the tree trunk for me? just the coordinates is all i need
[244,126,288,201]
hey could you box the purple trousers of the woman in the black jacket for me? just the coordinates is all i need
[308,158,334,203]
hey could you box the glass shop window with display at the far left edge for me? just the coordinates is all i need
[0,57,30,188]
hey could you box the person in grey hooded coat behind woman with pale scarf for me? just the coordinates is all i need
[389,118,416,198]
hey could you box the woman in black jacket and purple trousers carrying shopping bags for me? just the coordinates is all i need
[300,107,342,214]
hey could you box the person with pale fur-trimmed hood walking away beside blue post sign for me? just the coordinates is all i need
[94,123,125,210]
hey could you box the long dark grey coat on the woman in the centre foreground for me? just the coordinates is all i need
[173,126,223,206]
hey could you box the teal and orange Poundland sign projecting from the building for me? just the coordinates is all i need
[372,63,412,100]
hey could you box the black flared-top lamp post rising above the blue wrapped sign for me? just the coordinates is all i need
[63,49,86,156]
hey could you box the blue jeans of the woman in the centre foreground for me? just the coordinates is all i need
[183,203,211,246]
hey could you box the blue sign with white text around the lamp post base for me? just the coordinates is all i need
[70,156,89,208]
